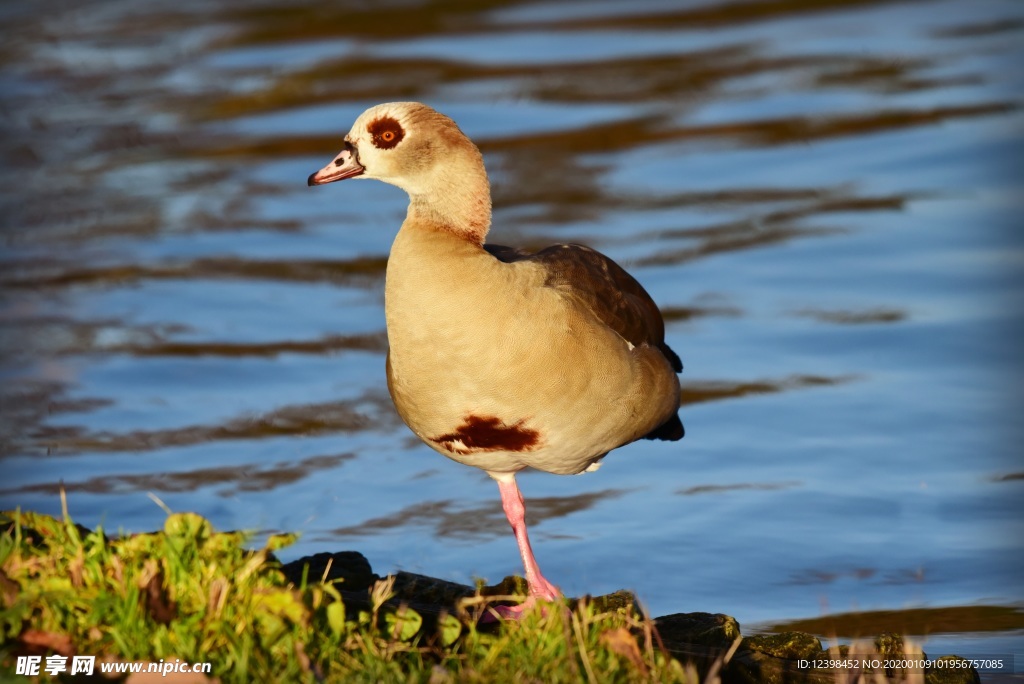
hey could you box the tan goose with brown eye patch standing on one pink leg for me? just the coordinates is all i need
[307,102,684,618]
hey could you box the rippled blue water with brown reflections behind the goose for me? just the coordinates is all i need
[0,0,1024,653]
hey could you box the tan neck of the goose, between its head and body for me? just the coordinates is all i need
[407,160,490,245]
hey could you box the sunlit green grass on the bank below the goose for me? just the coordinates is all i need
[0,511,698,684]
